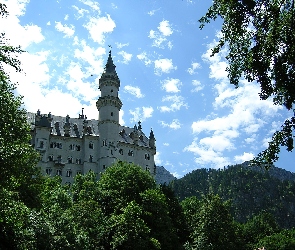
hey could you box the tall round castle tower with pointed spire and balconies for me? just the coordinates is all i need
[96,51,122,168]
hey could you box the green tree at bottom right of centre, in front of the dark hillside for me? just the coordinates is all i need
[182,194,240,250]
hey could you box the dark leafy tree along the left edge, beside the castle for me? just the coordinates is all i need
[0,4,40,206]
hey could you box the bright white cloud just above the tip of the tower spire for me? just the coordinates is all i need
[83,14,116,44]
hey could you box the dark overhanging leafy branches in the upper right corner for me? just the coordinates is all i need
[199,0,295,168]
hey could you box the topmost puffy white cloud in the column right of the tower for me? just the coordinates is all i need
[148,20,173,49]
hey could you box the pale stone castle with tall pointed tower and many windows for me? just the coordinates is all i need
[27,51,156,183]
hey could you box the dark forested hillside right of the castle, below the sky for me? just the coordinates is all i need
[171,164,295,228]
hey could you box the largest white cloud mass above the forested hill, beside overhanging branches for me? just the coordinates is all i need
[185,35,280,167]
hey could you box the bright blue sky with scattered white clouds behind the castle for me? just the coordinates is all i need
[0,0,295,178]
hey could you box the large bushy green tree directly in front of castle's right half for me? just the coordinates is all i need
[98,161,186,250]
